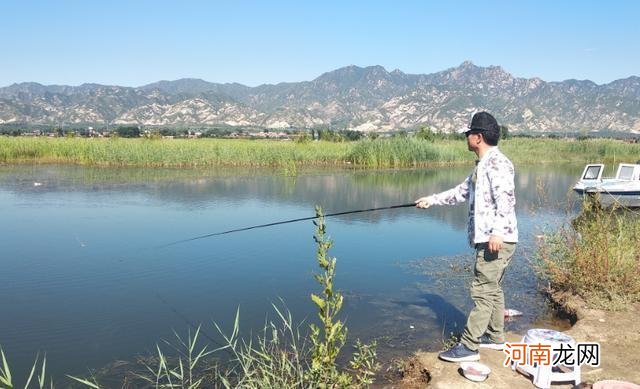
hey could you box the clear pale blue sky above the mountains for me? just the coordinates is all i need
[0,0,640,86]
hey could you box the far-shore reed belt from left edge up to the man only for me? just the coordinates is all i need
[0,137,469,168]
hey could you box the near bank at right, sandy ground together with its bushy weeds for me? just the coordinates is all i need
[401,202,640,388]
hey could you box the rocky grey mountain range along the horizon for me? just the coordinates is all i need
[0,61,640,133]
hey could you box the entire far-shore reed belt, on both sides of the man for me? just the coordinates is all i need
[0,136,637,167]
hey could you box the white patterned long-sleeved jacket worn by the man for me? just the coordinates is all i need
[432,147,518,246]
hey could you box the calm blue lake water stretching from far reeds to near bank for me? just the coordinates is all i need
[0,162,582,375]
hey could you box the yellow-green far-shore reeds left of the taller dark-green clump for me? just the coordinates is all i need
[0,137,349,167]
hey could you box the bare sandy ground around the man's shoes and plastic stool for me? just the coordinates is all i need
[382,295,640,389]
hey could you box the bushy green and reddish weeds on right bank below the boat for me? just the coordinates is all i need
[537,201,640,309]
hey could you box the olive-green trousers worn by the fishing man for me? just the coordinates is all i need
[460,243,516,350]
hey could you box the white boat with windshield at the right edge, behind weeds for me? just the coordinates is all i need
[573,161,640,207]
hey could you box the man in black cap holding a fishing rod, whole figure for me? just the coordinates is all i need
[415,112,518,362]
